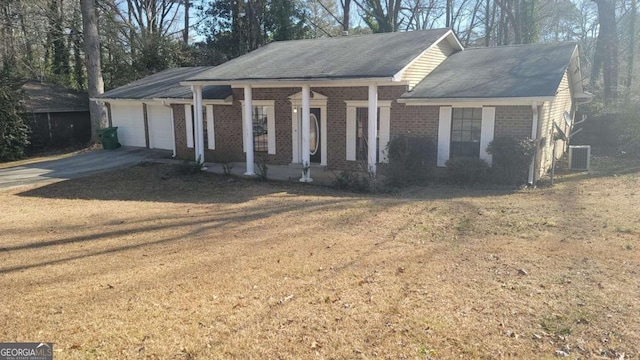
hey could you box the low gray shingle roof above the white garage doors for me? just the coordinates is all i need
[98,66,231,100]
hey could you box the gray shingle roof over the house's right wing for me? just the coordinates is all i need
[402,43,576,99]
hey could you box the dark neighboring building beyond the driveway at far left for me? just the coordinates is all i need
[22,80,91,149]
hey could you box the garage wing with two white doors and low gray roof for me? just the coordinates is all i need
[96,67,231,156]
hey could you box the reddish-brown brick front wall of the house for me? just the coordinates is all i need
[172,86,533,170]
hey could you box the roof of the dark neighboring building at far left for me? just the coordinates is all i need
[22,80,89,113]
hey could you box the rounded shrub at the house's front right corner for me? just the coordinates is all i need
[487,136,536,185]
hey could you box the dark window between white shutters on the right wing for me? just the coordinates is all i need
[450,108,482,158]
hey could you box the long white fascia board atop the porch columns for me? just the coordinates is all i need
[180,77,400,88]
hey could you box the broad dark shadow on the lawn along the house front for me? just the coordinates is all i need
[18,163,517,204]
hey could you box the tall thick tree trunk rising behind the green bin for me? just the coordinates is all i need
[80,0,107,142]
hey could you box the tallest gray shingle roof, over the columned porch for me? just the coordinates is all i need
[187,29,456,82]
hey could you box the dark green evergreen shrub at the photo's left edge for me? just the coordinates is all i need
[0,67,29,161]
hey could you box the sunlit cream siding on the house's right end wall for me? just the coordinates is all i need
[538,69,573,176]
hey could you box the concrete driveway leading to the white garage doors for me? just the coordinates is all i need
[0,148,171,189]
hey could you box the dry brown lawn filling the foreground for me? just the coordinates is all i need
[0,159,640,359]
